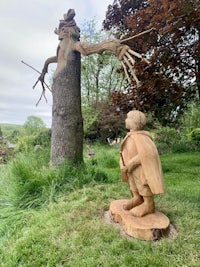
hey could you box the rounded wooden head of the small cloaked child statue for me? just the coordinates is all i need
[125,110,146,131]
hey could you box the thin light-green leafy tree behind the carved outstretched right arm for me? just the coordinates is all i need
[81,20,125,107]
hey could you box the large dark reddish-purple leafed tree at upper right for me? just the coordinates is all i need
[104,0,200,125]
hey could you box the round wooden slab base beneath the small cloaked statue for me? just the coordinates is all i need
[109,199,170,240]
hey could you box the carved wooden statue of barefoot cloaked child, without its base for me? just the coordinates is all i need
[120,110,165,217]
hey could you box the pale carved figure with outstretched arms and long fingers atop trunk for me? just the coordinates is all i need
[38,9,152,88]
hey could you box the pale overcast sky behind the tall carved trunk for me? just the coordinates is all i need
[0,0,113,127]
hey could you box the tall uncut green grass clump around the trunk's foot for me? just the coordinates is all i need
[0,146,118,208]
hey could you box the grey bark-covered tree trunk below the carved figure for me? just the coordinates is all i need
[51,51,83,166]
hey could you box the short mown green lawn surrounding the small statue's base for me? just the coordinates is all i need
[0,145,200,267]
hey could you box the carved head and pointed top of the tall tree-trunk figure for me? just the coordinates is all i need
[54,9,80,41]
